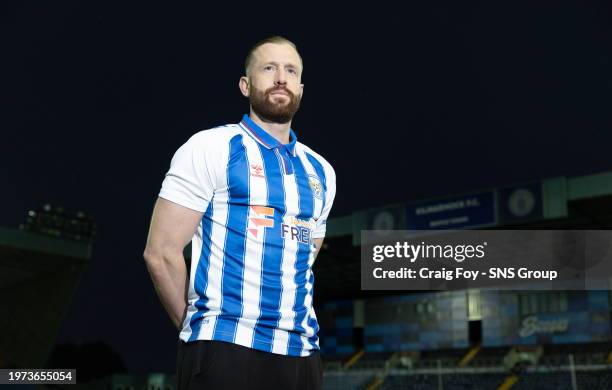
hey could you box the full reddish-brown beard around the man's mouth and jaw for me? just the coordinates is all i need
[249,85,302,123]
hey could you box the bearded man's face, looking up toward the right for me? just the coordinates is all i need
[243,43,304,123]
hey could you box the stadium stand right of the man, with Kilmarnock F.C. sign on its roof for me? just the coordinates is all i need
[315,172,612,390]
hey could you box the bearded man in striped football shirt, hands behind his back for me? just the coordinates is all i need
[144,37,336,389]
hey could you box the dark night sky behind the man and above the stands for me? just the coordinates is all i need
[0,1,612,372]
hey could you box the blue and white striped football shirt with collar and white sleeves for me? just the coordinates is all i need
[159,115,336,356]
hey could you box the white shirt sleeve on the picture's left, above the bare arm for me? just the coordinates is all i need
[159,136,215,212]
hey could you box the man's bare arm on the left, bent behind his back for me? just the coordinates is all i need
[144,198,203,329]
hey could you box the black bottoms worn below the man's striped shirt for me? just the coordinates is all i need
[177,340,323,390]
